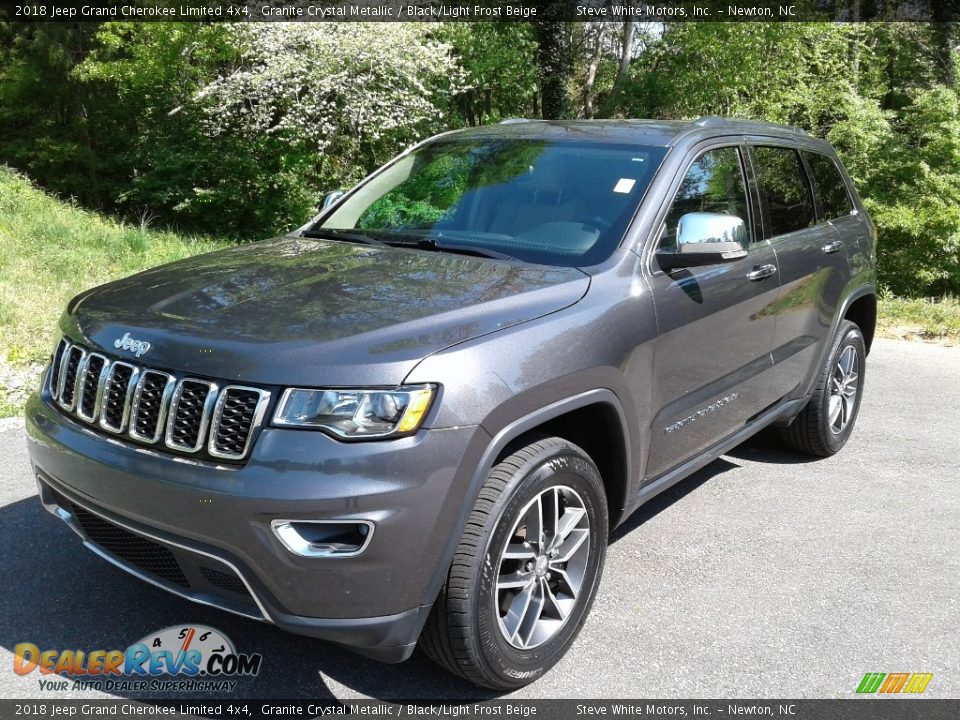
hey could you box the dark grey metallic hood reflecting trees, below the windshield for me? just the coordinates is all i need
[63,237,590,386]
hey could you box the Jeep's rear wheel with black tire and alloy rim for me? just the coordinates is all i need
[780,320,867,457]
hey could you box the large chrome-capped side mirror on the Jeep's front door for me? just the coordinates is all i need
[656,213,749,272]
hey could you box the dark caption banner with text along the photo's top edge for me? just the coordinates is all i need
[0,0,960,23]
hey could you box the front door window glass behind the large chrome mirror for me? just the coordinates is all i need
[660,147,750,248]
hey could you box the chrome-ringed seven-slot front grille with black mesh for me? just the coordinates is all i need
[49,340,270,461]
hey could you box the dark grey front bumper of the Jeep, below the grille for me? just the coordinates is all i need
[26,396,489,661]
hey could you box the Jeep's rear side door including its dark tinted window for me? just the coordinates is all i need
[750,141,849,399]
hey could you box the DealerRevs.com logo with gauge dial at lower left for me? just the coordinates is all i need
[13,625,263,692]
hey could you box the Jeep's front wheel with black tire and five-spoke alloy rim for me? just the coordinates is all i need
[420,438,608,689]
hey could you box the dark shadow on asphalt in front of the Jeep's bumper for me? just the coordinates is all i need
[0,497,498,701]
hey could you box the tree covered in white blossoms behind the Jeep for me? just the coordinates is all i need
[194,22,463,179]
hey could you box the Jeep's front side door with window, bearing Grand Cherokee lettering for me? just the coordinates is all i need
[646,142,779,481]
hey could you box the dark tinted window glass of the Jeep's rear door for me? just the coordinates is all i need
[753,147,816,237]
